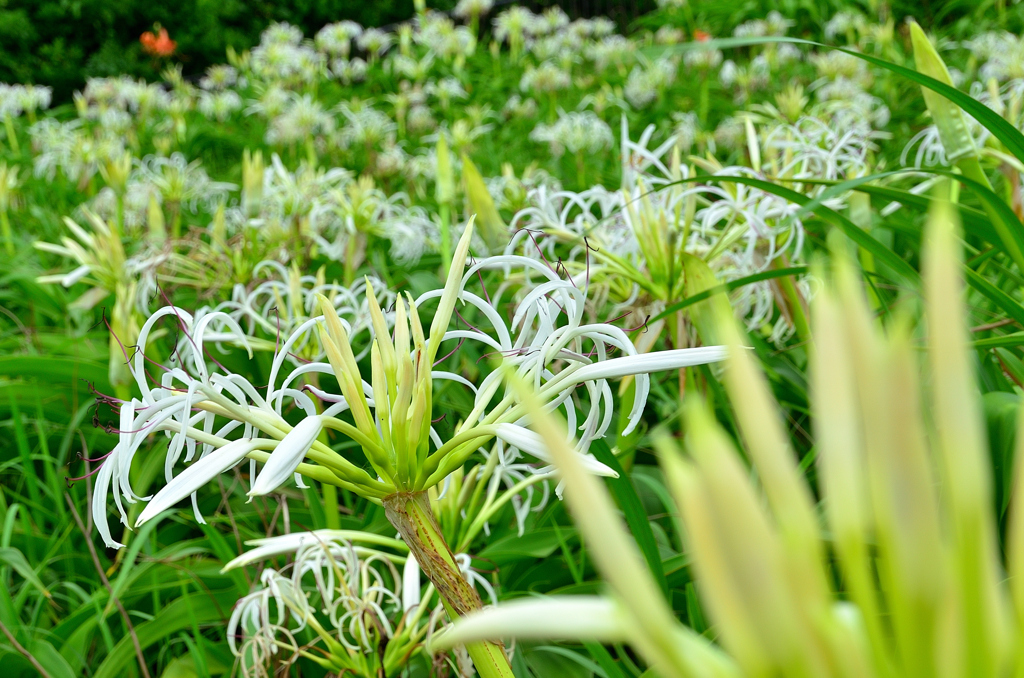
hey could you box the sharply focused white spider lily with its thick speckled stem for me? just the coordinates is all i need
[92,221,724,677]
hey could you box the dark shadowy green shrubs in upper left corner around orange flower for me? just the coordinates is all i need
[0,0,454,101]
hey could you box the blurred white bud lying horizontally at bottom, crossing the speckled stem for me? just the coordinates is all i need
[430,596,630,651]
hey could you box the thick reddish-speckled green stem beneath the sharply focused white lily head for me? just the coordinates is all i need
[383,492,515,678]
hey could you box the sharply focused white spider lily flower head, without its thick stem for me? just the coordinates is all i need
[97,218,723,553]
